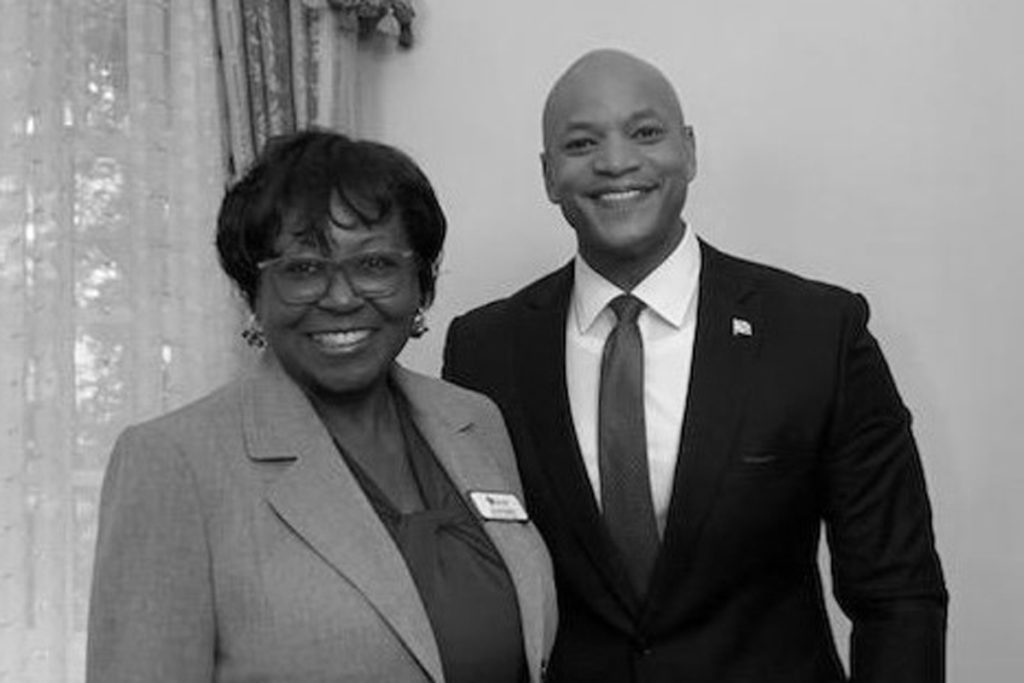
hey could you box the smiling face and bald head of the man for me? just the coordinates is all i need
[542,57,695,289]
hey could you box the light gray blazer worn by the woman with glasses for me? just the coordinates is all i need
[87,360,556,683]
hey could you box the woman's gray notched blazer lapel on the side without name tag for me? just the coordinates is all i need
[243,358,443,681]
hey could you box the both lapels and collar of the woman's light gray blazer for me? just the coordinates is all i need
[243,354,548,681]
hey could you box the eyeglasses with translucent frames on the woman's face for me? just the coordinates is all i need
[257,250,416,303]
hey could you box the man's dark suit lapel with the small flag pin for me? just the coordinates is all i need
[649,242,762,611]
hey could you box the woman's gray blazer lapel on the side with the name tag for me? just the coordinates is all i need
[392,366,553,683]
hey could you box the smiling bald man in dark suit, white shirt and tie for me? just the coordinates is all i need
[444,50,947,683]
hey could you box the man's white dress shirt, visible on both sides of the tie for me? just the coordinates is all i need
[565,225,700,533]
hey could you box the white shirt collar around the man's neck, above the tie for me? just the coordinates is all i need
[572,224,700,334]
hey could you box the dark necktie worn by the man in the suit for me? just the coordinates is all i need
[597,294,658,598]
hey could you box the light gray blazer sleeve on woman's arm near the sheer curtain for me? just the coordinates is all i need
[86,428,215,683]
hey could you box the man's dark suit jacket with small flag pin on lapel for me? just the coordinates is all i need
[444,244,947,683]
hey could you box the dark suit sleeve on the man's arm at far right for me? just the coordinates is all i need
[823,297,947,683]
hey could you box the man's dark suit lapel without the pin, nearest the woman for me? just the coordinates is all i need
[516,263,639,612]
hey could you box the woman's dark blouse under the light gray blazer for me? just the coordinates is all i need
[338,396,528,683]
